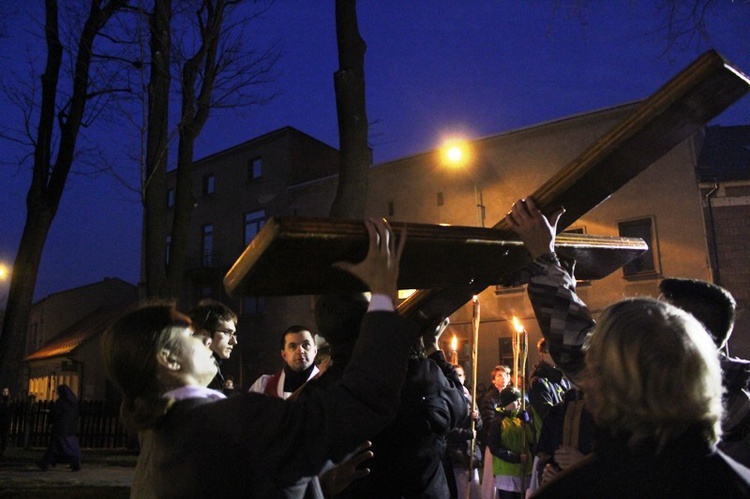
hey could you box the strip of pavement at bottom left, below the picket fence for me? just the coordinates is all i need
[0,448,138,499]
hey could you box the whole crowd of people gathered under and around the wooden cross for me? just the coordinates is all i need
[13,199,750,499]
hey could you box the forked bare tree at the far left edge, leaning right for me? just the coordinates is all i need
[0,0,128,391]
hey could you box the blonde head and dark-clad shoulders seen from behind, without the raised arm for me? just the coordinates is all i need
[534,298,750,498]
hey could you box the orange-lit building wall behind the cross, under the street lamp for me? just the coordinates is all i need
[356,107,710,382]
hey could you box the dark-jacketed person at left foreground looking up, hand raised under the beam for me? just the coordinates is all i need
[102,220,417,498]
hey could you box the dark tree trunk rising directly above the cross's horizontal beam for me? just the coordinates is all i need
[330,0,372,218]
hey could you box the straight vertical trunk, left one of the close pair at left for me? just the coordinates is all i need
[143,0,172,298]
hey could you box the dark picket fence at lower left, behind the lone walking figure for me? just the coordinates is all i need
[2,400,133,449]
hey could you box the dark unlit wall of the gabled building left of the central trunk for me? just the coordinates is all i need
[164,127,339,388]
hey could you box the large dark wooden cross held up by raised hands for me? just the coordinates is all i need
[224,51,750,328]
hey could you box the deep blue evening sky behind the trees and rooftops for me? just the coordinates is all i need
[0,0,750,302]
